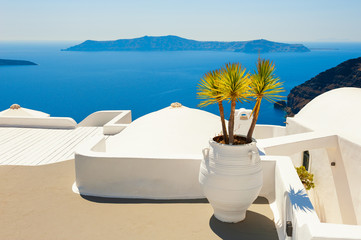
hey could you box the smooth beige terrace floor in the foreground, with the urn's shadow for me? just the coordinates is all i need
[0,160,278,240]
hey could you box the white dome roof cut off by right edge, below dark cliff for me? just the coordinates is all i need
[294,88,361,139]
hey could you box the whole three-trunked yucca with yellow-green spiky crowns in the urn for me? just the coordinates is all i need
[197,58,284,145]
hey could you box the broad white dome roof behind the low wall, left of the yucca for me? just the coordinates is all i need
[107,106,221,157]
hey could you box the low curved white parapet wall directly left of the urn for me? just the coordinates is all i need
[75,137,204,199]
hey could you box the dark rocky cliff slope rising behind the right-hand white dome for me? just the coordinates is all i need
[275,57,361,117]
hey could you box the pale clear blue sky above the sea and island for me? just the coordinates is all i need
[0,0,361,42]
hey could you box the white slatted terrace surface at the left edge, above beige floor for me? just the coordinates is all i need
[0,127,103,165]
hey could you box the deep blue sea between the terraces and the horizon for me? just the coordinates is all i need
[0,42,361,125]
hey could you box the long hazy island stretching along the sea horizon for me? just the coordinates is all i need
[62,36,310,53]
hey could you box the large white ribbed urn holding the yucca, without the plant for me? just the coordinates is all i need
[199,140,263,223]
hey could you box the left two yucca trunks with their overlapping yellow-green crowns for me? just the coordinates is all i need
[197,63,250,144]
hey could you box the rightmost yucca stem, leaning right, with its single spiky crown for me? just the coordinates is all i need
[247,58,285,143]
